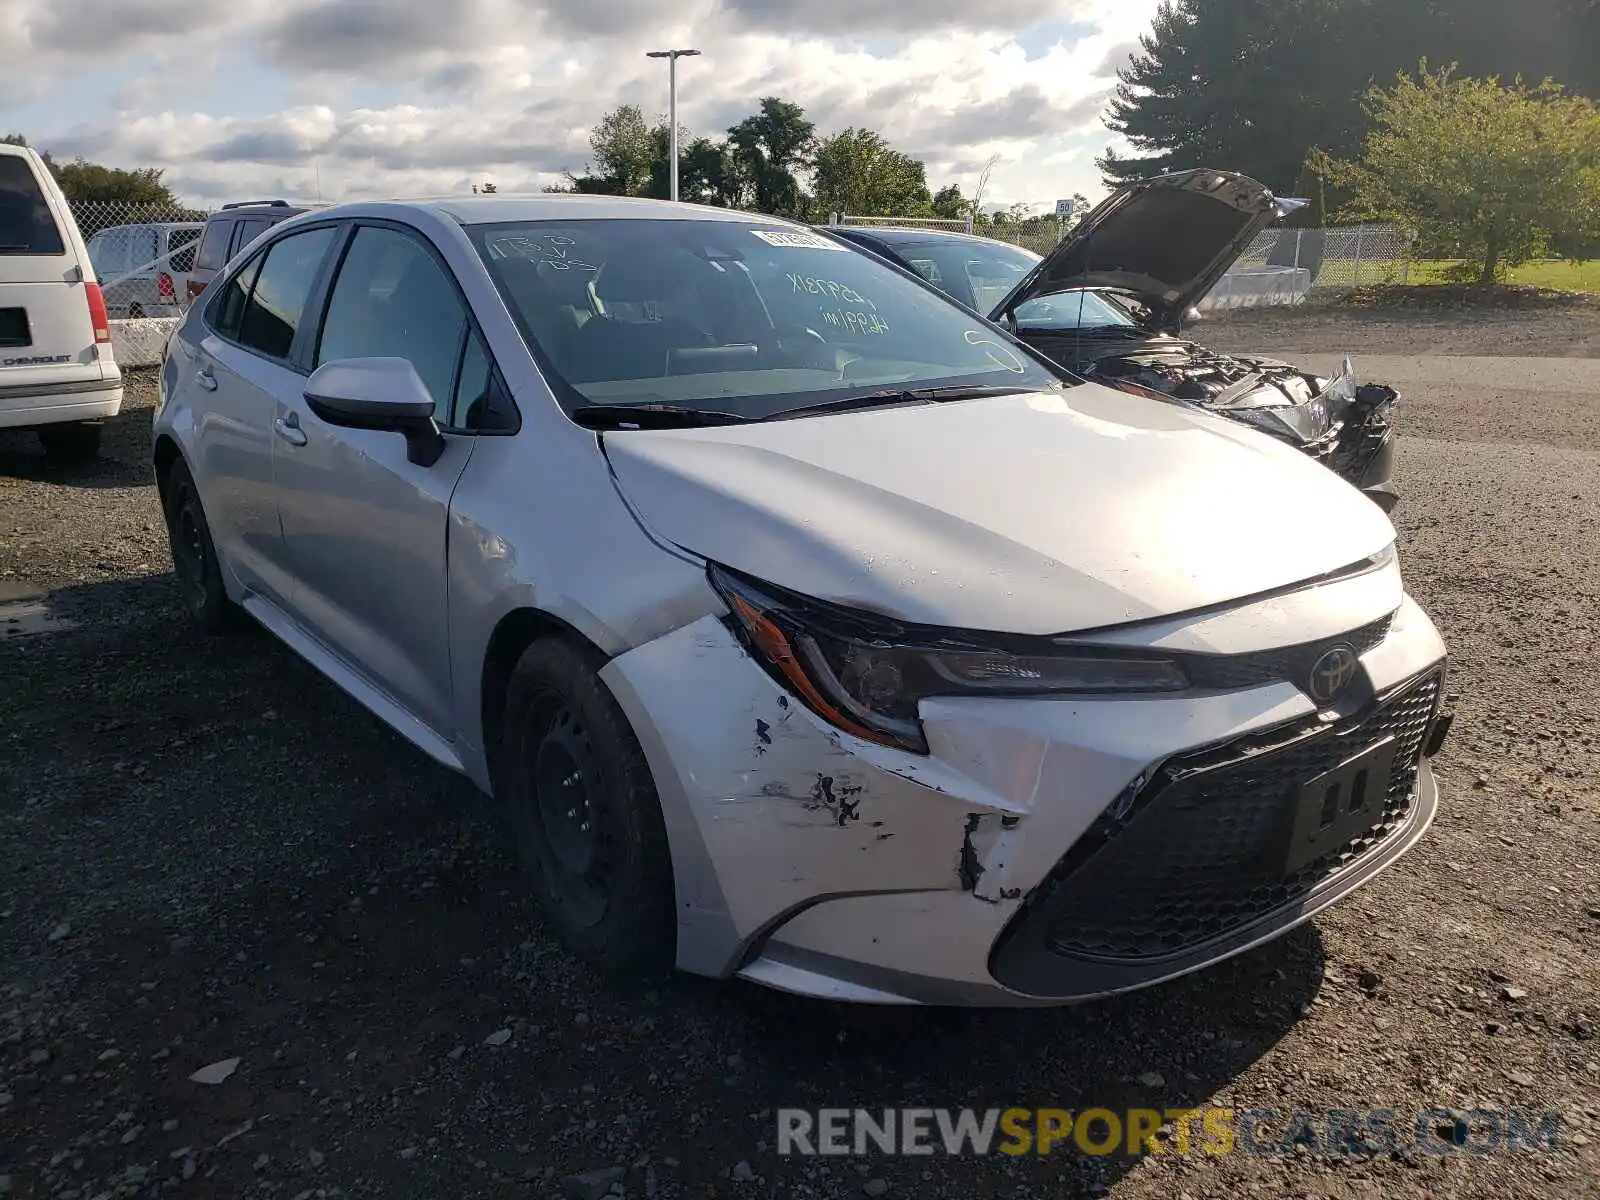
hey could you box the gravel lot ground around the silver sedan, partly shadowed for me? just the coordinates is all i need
[0,312,1600,1200]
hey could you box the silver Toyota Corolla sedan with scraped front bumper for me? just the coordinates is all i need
[154,195,1450,1005]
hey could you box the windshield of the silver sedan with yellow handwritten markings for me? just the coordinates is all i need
[467,219,1064,419]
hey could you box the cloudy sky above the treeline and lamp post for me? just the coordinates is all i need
[0,0,1157,206]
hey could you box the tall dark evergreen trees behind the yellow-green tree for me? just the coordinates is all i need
[1099,0,1600,195]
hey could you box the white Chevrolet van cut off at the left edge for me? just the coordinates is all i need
[0,146,122,459]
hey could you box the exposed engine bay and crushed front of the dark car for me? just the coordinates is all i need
[1019,330,1400,509]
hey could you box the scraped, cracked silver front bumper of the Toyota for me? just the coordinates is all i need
[602,587,1443,1005]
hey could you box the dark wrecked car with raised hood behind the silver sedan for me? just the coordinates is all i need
[829,171,1400,510]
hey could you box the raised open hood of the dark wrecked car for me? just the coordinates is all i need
[990,170,1306,325]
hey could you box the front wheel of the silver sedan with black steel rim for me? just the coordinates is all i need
[496,638,677,978]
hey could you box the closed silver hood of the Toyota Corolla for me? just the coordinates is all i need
[603,384,1394,634]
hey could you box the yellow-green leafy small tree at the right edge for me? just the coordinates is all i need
[1322,70,1600,283]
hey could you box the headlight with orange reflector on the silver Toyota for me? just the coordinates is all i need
[709,565,1189,754]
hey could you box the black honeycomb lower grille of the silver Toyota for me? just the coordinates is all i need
[998,674,1442,960]
